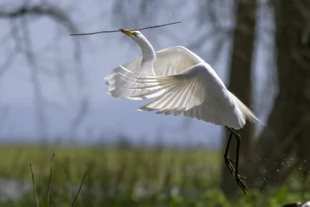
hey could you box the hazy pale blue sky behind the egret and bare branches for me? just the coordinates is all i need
[0,0,275,146]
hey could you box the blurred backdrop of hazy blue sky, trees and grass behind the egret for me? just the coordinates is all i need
[0,0,310,207]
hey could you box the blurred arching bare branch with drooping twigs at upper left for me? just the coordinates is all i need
[0,2,89,136]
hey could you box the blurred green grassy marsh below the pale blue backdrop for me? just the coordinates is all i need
[0,146,301,207]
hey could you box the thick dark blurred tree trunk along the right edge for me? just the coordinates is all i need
[253,0,310,188]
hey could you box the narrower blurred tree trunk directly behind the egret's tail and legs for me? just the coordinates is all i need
[221,0,257,197]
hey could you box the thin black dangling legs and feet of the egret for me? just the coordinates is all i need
[225,127,248,195]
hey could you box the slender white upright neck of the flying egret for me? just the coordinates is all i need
[138,38,156,75]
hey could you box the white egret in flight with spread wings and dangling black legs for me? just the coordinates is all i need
[105,29,258,194]
